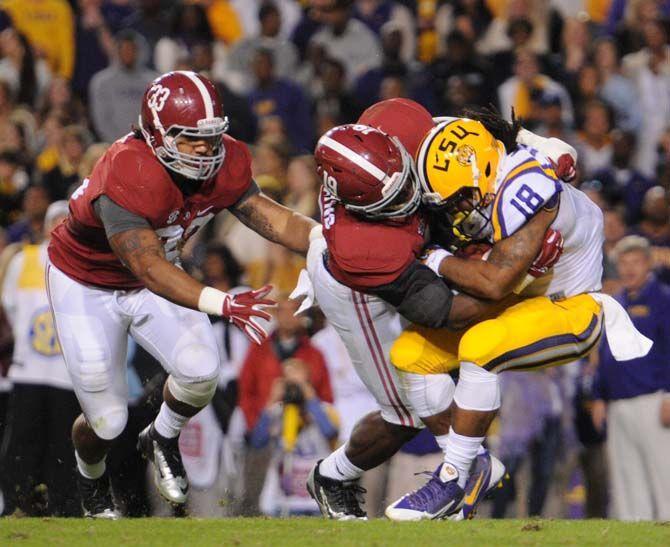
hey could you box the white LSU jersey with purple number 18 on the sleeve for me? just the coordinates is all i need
[492,145,604,297]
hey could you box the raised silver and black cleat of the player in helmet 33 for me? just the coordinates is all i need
[137,424,188,505]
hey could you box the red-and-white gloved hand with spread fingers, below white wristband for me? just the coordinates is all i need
[221,285,277,344]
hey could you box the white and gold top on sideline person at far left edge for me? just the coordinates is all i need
[2,243,72,389]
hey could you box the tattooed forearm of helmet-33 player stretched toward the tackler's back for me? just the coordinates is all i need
[231,193,317,254]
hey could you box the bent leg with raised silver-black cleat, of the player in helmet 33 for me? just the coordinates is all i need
[127,290,219,505]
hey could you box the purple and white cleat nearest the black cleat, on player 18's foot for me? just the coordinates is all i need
[385,462,464,521]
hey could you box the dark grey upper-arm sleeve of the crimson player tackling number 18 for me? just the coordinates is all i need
[369,260,454,328]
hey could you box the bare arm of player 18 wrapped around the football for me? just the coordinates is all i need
[439,210,557,300]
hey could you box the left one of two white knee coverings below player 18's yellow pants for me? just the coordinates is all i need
[402,372,456,418]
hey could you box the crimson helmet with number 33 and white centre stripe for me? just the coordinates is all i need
[139,70,228,180]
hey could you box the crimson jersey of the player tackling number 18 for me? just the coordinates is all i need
[320,189,426,291]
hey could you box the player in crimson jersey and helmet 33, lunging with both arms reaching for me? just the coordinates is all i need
[47,72,316,518]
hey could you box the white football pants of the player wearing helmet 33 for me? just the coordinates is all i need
[46,264,219,439]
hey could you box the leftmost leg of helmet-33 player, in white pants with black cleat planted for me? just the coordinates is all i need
[47,265,128,519]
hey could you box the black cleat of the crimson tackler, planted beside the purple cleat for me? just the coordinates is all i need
[307,460,368,520]
